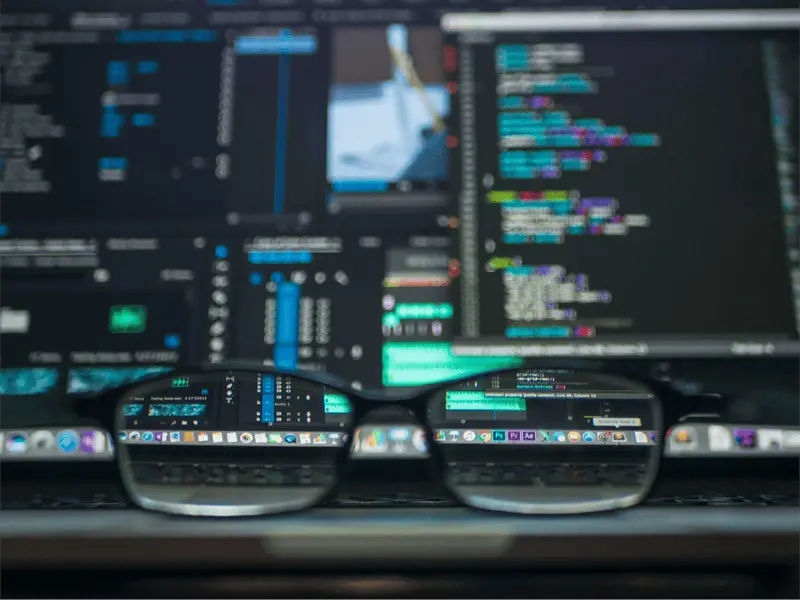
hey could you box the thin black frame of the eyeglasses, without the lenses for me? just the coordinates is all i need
[76,362,665,518]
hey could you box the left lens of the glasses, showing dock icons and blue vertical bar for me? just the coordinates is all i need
[117,372,350,516]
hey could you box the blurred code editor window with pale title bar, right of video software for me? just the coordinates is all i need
[443,11,798,356]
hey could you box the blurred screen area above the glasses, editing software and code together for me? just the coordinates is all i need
[0,0,800,410]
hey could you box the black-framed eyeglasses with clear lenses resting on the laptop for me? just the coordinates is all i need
[83,368,663,517]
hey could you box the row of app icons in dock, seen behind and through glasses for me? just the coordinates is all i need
[7,423,800,461]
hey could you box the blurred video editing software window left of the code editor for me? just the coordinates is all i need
[0,1,519,396]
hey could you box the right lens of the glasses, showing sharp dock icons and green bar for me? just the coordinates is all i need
[429,369,661,514]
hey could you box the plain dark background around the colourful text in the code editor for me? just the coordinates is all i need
[460,32,795,339]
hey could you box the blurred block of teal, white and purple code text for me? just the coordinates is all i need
[485,43,661,339]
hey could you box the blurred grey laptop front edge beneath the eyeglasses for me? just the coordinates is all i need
[0,508,800,569]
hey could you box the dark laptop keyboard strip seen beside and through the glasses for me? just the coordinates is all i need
[0,463,800,510]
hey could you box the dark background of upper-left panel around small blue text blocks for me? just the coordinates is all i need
[2,38,226,226]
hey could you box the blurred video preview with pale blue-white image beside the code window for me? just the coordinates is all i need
[327,23,450,213]
